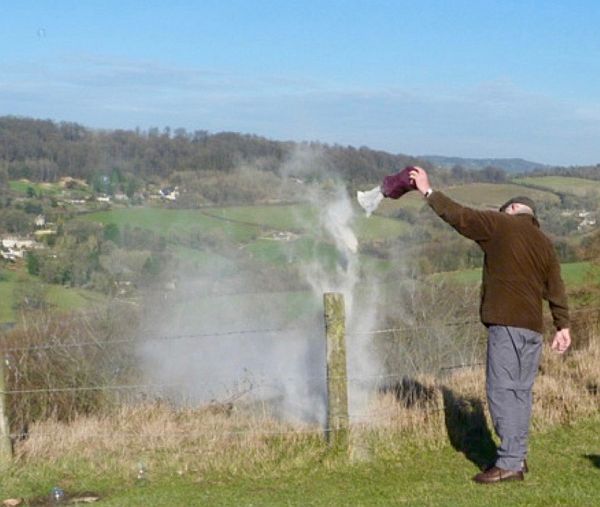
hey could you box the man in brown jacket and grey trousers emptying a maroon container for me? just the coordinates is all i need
[410,167,571,483]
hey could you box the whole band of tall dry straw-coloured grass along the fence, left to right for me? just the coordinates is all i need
[10,332,600,480]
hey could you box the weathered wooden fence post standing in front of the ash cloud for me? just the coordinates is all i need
[323,292,348,450]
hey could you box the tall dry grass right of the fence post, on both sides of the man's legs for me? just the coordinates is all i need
[358,334,600,456]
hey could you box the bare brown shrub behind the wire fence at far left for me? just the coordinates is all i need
[0,304,137,433]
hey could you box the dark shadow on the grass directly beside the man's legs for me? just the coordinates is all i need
[442,387,496,470]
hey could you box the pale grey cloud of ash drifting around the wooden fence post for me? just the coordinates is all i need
[140,146,381,424]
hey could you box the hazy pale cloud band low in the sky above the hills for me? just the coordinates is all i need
[0,55,600,164]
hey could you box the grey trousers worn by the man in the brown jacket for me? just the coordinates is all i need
[486,326,542,470]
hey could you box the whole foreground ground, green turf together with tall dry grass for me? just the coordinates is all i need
[0,327,600,507]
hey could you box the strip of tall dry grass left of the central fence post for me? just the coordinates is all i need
[10,402,322,478]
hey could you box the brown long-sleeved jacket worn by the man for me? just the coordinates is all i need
[427,191,569,333]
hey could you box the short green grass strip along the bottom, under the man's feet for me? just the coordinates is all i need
[5,417,600,507]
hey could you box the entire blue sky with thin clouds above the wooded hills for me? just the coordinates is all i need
[0,0,600,165]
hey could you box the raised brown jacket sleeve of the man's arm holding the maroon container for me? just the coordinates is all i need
[427,190,497,241]
